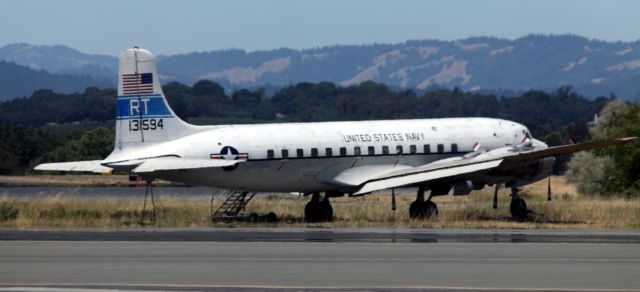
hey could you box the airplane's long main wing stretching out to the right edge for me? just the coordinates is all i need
[354,137,640,195]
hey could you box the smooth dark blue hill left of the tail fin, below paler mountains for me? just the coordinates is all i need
[0,61,114,101]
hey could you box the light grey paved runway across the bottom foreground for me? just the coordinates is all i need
[0,229,640,291]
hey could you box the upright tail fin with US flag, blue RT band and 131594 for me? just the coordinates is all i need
[115,47,196,151]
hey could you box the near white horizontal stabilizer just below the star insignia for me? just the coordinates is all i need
[133,157,245,173]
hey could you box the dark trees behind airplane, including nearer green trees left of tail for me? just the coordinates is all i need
[0,80,611,174]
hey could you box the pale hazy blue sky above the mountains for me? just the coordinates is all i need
[0,0,640,55]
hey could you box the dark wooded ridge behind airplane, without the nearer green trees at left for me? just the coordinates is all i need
[0,80,611,139]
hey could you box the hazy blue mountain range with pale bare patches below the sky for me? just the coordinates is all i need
[0,35,640,100]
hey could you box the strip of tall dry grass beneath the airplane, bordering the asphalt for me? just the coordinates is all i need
[0,178,640,229]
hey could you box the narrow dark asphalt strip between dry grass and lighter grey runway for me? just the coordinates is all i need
[0,228,640,244]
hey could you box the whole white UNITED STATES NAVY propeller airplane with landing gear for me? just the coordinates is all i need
[35,47,638,221]
